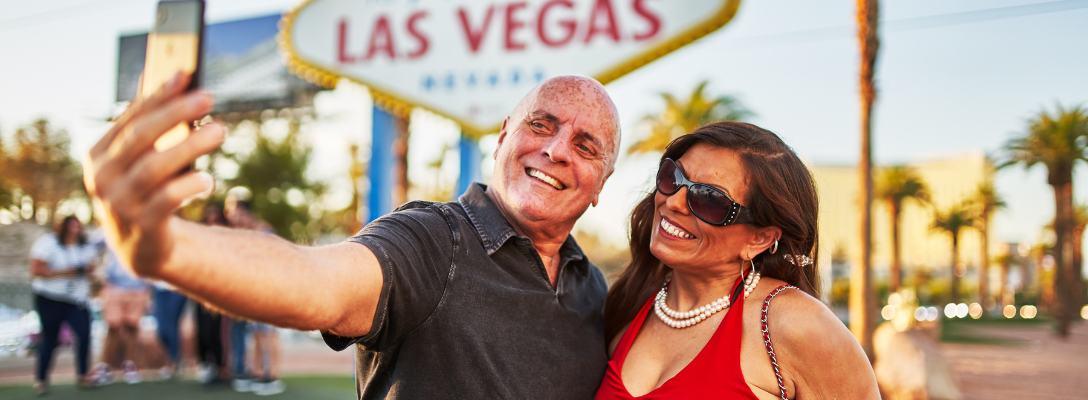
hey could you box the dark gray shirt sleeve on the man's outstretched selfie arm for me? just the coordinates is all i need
[322,202,459,351]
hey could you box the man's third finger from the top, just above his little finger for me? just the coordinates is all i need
[126,124,224,198]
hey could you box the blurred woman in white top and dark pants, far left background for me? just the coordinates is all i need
[30,216,98,395]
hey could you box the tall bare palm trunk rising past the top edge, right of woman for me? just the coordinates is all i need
[850,0,880,361]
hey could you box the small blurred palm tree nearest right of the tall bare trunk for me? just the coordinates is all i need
[876,165,929,292]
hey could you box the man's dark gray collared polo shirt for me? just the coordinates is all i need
[323,184,608,399]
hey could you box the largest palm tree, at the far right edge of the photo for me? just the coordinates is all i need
[1002,104,1088,337]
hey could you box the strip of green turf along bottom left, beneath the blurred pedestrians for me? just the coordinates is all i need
[0,376,356,400]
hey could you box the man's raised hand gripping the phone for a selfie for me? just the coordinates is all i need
[83,74,224,277]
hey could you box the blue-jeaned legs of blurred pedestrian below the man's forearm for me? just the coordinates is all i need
[152,282,188,380]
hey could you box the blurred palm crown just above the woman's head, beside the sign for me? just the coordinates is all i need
[627,80,752,154]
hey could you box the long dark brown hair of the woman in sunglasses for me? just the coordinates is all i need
[604,122,819,340]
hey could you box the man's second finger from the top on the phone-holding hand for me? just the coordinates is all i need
[110,91,215,166]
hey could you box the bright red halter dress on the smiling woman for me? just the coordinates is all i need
[596,282,758,400]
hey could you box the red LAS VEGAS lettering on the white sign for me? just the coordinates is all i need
[336,0,662,64]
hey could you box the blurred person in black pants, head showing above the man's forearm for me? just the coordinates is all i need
[196,204,228,386]
